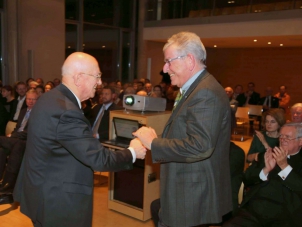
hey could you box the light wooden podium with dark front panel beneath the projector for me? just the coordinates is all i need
[103,110,171,221]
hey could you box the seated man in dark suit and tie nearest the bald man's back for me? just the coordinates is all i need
[0,90,38,204]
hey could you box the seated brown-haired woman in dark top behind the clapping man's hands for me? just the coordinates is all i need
[247,109,285,162]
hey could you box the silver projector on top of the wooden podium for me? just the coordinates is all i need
[123,95,167,111]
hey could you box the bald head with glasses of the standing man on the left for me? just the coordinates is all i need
[62,52,102,101]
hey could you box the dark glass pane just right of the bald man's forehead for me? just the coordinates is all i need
[83,24,119,82]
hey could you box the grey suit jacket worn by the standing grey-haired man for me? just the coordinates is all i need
[151,70,232,227]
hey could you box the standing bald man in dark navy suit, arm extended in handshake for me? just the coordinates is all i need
[14,52,146,227]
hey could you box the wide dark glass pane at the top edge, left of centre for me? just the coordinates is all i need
[84,0,135,28]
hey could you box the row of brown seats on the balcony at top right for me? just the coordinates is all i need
[189,1,302,18]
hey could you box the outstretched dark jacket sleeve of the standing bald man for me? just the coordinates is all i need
[56,110,133,171]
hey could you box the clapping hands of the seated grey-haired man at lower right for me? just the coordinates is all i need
[263,147,288,174]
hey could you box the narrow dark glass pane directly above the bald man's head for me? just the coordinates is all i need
[65,24,81,57]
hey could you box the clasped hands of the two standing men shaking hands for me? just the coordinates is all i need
[130,127,157,159]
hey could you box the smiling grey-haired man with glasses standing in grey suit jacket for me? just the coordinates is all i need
[134,32,232,227]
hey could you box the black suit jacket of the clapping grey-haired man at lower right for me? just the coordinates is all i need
[241,151,302,226]
